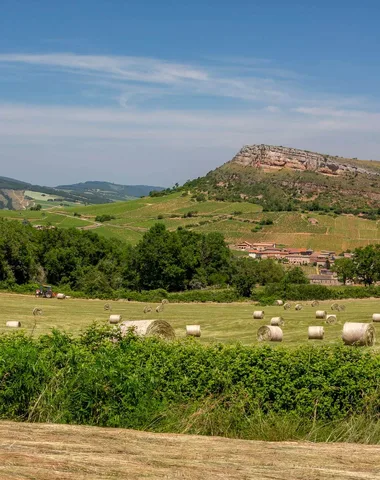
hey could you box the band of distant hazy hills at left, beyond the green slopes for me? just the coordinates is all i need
[0,177,162,210]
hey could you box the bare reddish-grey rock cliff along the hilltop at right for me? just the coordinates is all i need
[231,145,378,175]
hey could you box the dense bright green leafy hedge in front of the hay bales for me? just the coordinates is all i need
[0,326,380,431]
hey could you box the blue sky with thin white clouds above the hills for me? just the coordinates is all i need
[0,0,380,186]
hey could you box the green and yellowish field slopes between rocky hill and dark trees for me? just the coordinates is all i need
[0,193,380,253]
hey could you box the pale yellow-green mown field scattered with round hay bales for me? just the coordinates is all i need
[0,293,380,348]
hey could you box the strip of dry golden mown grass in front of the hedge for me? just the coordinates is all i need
[0,422,380,480]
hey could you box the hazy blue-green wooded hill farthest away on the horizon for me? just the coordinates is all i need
[56,181,163,201]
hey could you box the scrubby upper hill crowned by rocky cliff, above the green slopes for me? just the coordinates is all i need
[185,145,380,213]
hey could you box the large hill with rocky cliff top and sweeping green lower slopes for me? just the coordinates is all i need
[1,145,380,252]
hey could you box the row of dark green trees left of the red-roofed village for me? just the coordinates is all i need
[0,220,314,297]
